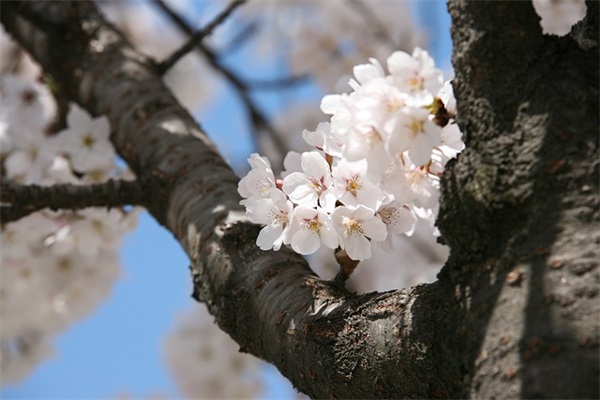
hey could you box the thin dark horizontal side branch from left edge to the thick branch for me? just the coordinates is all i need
[0,180,143,224]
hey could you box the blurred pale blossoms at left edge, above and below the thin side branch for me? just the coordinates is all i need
[0,71,137,384]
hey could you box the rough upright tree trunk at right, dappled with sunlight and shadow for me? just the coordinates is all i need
[439,1,599,398]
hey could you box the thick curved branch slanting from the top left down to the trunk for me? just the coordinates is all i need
[1,1,460,398]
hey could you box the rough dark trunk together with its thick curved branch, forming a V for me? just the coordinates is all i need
[1,1,600,398]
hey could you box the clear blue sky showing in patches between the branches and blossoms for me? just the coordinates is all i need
[0,0,451,399]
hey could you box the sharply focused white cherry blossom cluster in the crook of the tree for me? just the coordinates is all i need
[238,48,464,261]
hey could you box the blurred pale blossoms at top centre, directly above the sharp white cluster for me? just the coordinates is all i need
[242,0,420,92]
